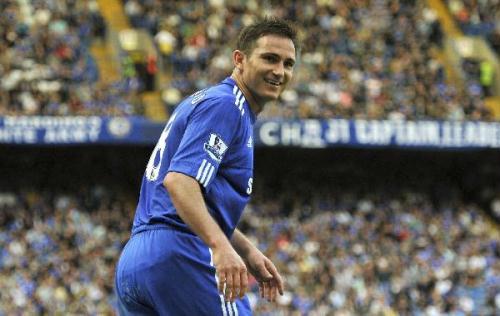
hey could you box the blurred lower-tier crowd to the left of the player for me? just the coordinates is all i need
[0,188,135,316]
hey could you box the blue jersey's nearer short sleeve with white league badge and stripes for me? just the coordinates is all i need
[168,98,242,188]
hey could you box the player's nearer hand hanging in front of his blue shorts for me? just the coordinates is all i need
[212,243,248,302]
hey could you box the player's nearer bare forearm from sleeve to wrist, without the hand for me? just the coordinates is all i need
[163,172,229,249]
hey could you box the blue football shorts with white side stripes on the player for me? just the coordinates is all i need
[115,225,252,316]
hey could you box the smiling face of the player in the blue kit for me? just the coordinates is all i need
[239,35,295,104]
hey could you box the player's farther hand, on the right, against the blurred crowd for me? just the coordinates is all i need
[246,248,284,302]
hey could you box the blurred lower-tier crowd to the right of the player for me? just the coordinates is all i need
[242,188,500,315]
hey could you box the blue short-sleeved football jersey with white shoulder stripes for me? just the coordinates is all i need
[134,77,255,238]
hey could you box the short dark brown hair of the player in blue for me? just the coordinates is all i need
[236,17,299,54]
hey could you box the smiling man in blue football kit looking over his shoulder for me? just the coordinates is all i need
[115,18,297,316]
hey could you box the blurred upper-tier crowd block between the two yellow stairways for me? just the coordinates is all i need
[124,0,491,120]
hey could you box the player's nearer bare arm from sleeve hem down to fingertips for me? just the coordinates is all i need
[163,172,248,301]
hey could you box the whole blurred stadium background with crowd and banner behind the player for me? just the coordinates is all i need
[0,0,500,315]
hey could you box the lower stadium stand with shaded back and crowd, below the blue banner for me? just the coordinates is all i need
[0,147,500,315]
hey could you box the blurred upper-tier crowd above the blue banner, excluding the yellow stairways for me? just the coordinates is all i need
[0,0,492,120]
